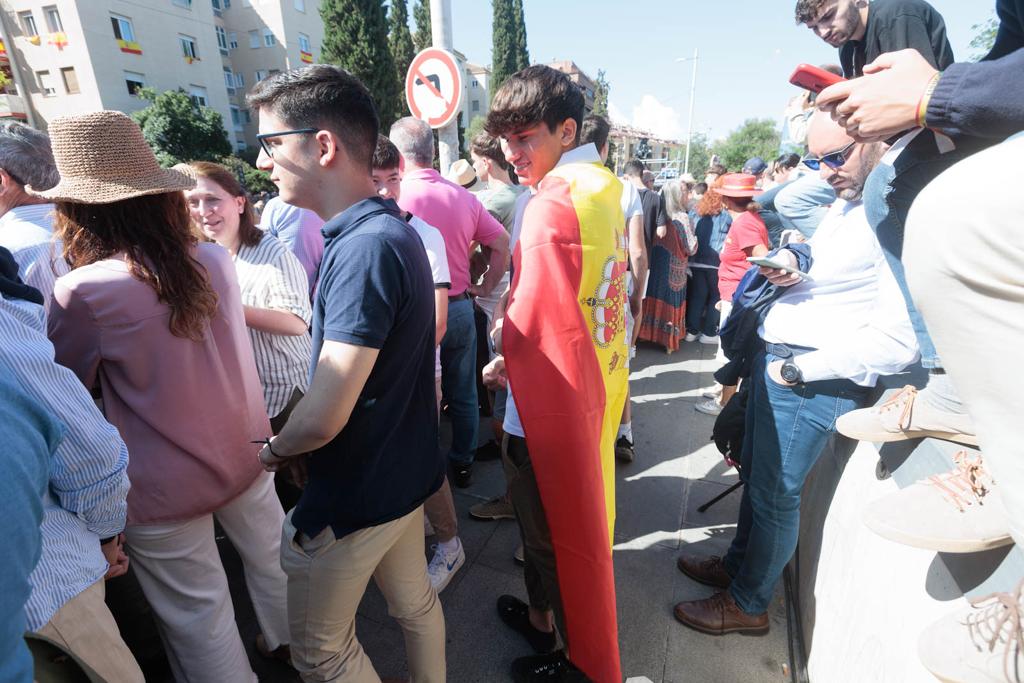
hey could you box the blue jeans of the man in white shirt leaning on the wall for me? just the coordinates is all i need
[725,352,870,614]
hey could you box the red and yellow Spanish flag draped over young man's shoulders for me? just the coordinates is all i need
[502,154,629,683]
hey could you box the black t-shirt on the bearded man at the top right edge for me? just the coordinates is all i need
[839,0,953,78]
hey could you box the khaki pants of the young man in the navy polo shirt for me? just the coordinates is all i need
[281,507,445,683]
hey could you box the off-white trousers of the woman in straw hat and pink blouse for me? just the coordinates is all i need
[125,472,289,683]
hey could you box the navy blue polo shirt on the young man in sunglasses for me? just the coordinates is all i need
[292,198,444,539]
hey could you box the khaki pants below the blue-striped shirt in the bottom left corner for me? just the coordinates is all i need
[39,579,145,683]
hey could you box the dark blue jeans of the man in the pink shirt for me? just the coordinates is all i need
[441,299,480,465]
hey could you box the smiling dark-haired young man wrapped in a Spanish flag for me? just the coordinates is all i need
[485,66,629,683]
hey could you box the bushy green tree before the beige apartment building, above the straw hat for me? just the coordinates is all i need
[132,88,231,167]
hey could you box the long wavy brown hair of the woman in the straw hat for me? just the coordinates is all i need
[54,193,217,342]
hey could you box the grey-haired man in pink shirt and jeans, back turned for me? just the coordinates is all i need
[389,117,509,488]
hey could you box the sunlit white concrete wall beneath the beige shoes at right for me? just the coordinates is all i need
[795,375,1024,683]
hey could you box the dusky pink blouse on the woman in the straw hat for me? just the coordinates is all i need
[49,244,270,524]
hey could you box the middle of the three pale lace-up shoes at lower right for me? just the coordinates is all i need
[863,451,1014,553]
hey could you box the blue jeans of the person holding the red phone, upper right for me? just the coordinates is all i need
[864,130,975,370]
